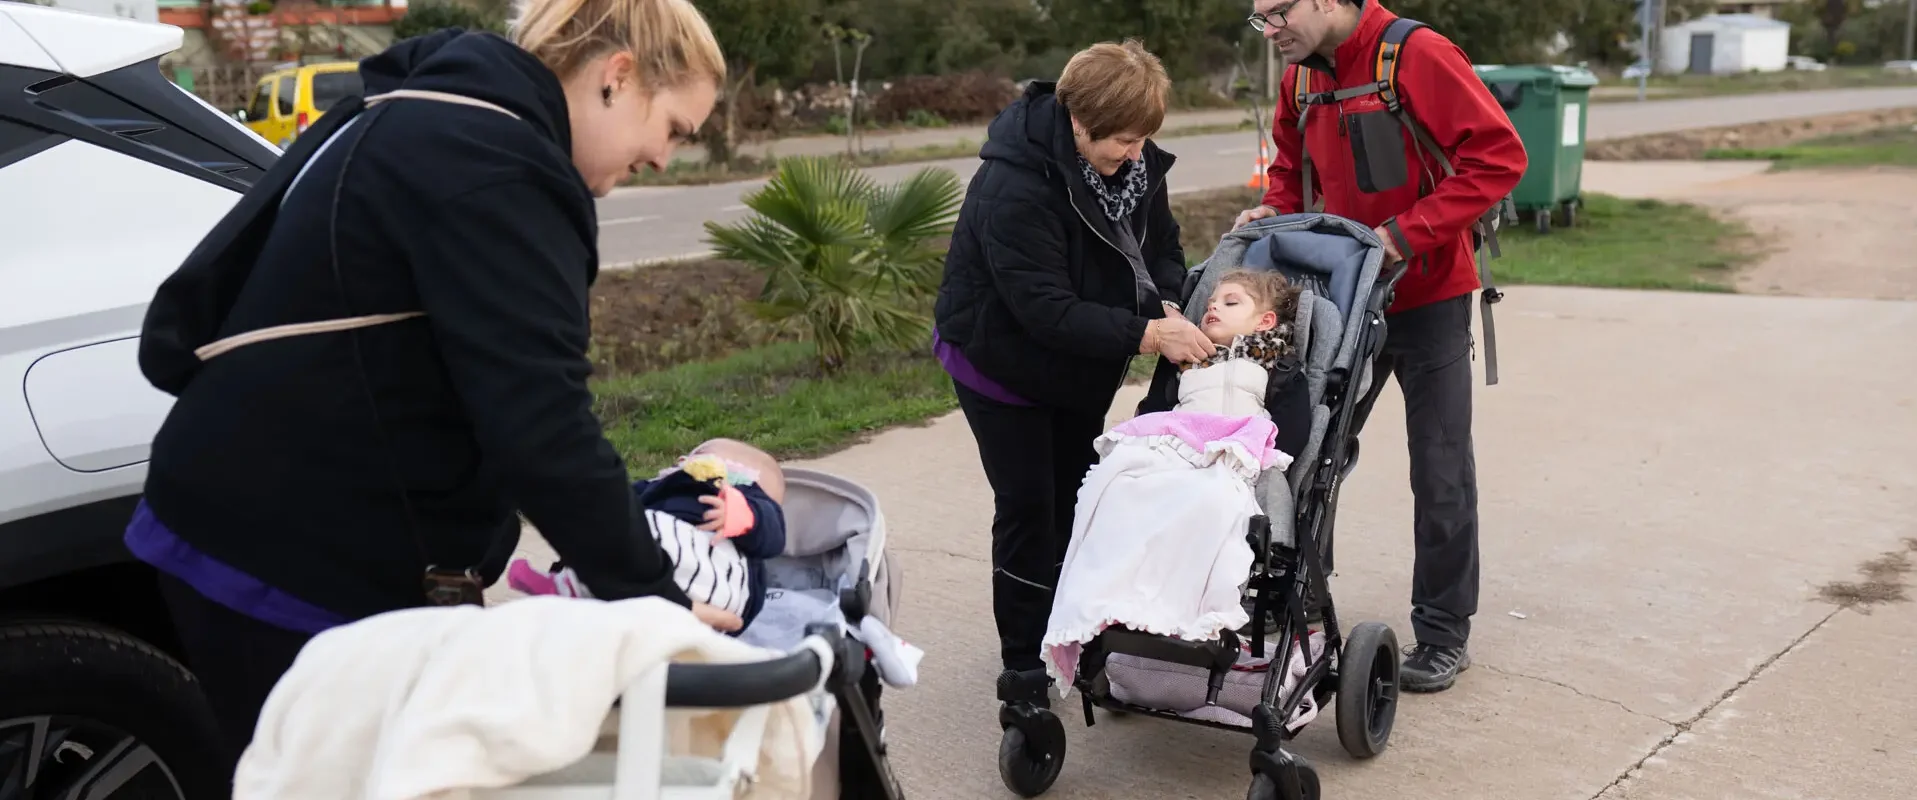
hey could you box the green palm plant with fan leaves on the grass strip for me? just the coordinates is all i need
[705,157,960,372]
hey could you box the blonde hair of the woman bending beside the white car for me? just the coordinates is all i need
[512,0,725,88]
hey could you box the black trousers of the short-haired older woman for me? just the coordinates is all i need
[953,382,1104,671]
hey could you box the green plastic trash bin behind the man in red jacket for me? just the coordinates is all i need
[1478,65,1597,234]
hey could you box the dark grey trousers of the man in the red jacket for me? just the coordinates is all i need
[1365,294,1478,647]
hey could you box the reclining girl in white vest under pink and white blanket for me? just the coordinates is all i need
[1041,269,1309,693]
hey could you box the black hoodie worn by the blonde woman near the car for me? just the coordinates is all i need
[140,31,690,618]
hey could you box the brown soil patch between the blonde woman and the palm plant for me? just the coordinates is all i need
[592,259,796,378]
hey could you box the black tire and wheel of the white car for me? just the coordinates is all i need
[0,620,230,800]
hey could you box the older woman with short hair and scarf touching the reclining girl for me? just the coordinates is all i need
[934,42,1212,704]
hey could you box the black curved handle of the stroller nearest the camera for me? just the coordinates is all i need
[665,625,865,708]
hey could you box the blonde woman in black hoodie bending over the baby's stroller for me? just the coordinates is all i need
[127,0,738,775]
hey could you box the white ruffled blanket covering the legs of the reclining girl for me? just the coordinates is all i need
[1041,432,1261,694]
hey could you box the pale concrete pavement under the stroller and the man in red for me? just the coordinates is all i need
[766,286,1917,800]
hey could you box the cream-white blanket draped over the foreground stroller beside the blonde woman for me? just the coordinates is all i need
[234,597,822,800]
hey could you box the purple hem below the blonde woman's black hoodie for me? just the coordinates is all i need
[125,499,349,633]
